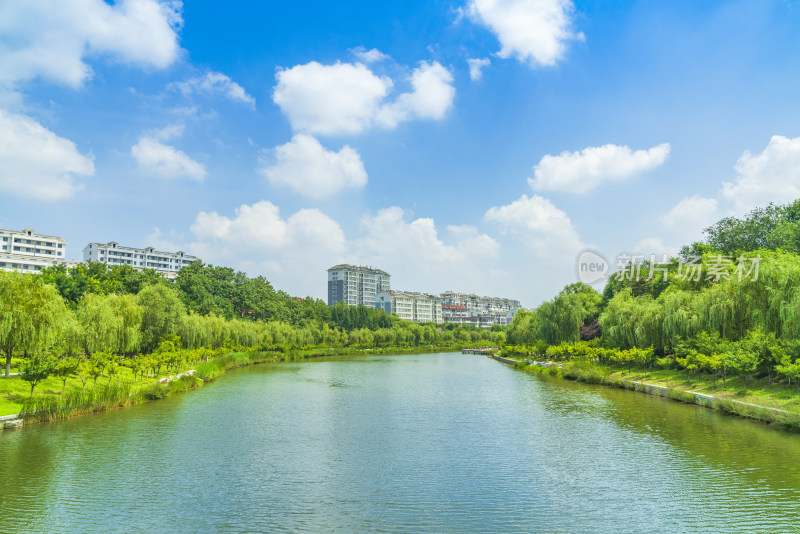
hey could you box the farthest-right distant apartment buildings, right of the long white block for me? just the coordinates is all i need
[439,291,522,328]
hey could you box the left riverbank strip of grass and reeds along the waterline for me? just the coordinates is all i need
[0,345,472,430]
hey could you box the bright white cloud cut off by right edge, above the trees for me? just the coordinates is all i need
[722,135,800,213]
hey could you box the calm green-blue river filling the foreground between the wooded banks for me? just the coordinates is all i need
[0,354,800,533]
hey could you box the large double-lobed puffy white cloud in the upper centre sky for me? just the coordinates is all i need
[273,61,455,135]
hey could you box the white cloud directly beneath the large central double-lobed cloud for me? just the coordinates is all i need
[259,134,367,198]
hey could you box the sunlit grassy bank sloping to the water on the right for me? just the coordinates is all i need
[506,361,800,431]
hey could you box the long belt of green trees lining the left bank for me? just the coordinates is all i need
[0,262,504,395]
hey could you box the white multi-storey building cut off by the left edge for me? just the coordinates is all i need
[0,228,67,273]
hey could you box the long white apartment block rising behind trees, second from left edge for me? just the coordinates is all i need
[83,241,200,277]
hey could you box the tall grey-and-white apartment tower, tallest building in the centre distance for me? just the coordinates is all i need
[328,264,391,308]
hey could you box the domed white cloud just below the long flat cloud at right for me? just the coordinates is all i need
[484,195,583,256]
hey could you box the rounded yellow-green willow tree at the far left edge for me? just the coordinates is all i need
[0,271,68,376]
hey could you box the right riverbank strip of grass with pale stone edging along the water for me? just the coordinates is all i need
[494,356,800,432]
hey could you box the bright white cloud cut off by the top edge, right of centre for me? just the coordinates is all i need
[467,0,583,65]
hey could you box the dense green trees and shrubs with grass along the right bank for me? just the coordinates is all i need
[501,200,800,428]
